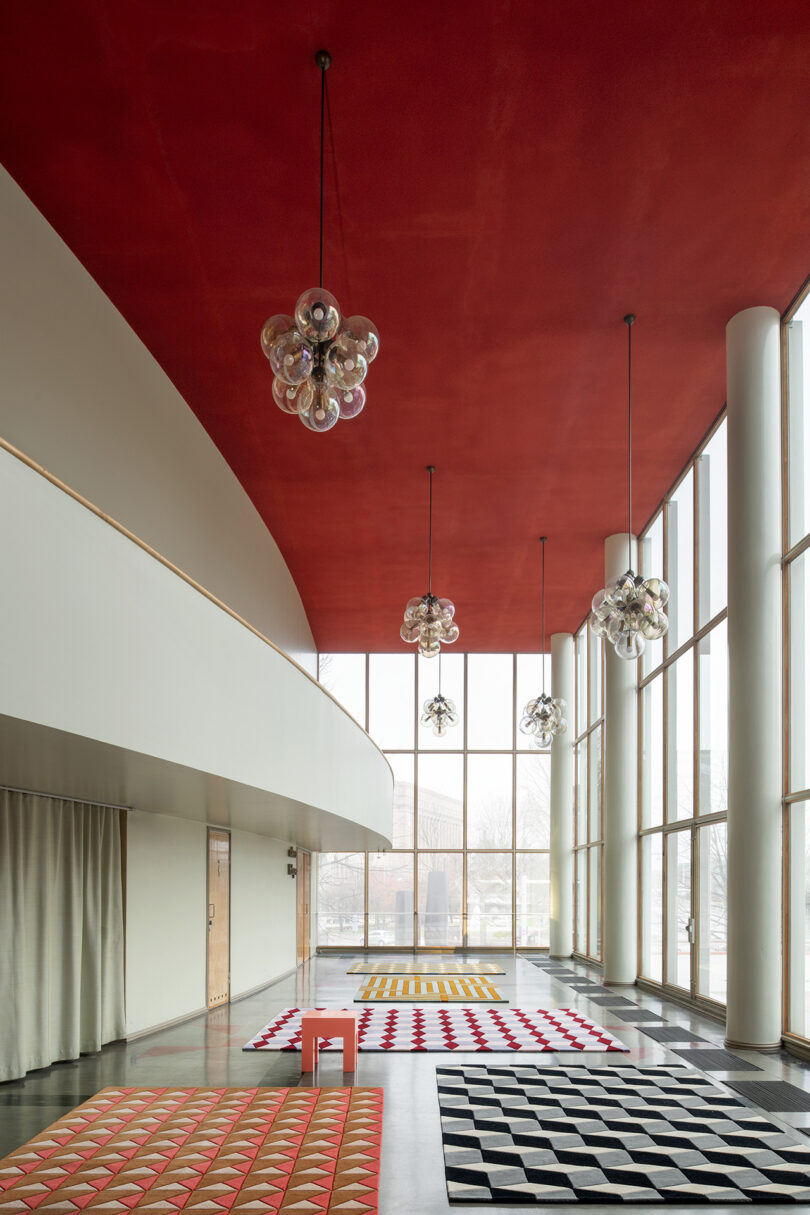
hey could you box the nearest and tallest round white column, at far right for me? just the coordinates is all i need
[726,307,782,1050]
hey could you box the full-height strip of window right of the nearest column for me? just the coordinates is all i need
[782,281,810,1040]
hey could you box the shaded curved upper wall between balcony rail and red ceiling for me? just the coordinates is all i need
[0,169,316,674]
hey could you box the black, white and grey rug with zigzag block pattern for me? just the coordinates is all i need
[436,1063,810,1204]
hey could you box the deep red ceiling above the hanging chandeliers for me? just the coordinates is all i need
[0,0,810,650]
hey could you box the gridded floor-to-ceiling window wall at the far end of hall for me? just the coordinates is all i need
[317,651,551,949]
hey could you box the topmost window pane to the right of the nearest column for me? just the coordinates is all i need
[784,298,810,546]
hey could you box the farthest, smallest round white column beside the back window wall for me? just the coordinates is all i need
[549,633,576,957]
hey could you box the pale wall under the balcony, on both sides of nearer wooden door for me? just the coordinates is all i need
[126,812,296,1035]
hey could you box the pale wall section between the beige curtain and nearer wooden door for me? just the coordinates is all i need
[126,812,206,1034]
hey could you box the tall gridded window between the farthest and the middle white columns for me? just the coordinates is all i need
[571,623,605,960]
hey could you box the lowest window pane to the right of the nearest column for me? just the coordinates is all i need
[787,802,810,1038]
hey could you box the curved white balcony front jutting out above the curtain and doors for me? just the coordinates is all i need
[0,450,393,855]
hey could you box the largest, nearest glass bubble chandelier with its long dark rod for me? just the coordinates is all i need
[261,51,380,433]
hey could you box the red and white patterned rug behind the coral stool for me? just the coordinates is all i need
[243,1007,628,1051]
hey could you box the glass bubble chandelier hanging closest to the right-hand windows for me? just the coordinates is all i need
[588,312,669,660]
